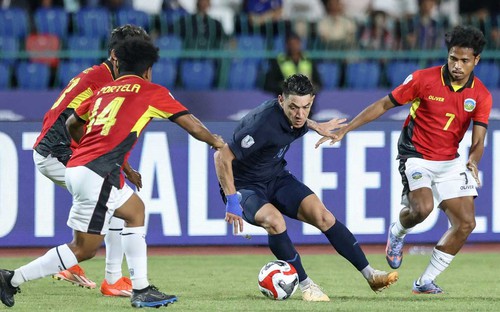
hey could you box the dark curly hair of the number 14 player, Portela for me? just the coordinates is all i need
[115,38,159,76]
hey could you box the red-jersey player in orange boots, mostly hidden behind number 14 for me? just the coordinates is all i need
[33,25,151,297]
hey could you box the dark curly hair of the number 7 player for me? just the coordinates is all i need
[445,26,486,56]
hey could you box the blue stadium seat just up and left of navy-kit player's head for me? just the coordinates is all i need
[228,59,259,90]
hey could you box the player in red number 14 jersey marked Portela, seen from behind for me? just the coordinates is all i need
[0,39,224,307]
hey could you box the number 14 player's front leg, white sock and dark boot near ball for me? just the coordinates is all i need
[114,193,177,308]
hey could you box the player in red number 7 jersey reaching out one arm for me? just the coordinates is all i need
[317,26,492,294]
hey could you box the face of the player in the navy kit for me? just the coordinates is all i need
[278,94,314,128]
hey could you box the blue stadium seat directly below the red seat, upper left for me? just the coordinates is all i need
[16,62,50,90]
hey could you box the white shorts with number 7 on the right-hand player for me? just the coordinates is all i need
[400,158,477,206]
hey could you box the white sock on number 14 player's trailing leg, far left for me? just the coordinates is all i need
[11,244,78,287]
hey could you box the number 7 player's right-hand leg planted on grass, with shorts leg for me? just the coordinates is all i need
[413,160,477,294]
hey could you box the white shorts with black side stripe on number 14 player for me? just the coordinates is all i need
[66,166,134,235]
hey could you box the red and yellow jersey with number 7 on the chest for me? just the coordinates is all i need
[389,65,492,160]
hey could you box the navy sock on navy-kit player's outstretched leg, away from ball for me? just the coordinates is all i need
[323,220,369,271]
